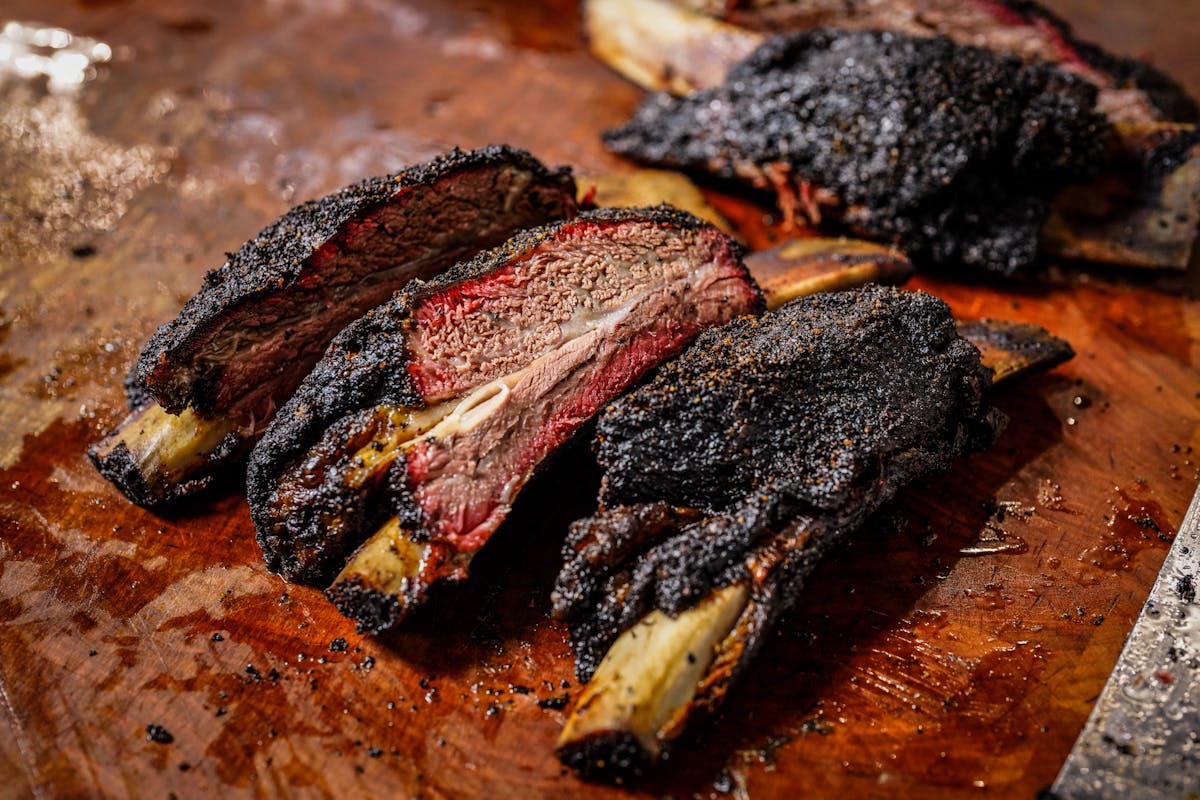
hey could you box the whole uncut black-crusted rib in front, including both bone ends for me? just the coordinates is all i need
[553,287,1070,777]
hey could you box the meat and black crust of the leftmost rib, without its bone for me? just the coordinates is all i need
[133,145,576,420]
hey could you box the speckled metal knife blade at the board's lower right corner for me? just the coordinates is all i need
[1049,479,1200,800]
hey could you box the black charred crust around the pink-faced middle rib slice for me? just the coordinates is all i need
[247,206,762,583]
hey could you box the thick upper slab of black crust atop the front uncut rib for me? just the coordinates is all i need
[596,287,990,510]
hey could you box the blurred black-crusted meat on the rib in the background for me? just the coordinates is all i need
[605,30,1110,276]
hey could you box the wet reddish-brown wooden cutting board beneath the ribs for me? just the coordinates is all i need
[0,0,1200,799]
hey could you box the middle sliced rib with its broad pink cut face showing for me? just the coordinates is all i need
[250,209,762,628]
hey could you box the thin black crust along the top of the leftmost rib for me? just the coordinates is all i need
[132,145,575,414]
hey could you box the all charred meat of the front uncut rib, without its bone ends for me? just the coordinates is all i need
[554,287,1003,678]
